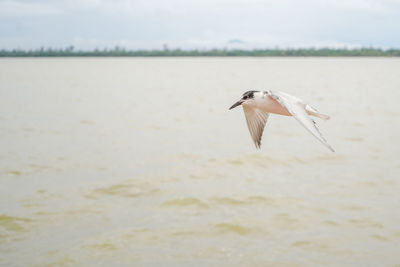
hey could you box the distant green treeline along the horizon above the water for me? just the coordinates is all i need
[0,46,400,57]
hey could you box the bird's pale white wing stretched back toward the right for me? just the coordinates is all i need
[270,91,334,152]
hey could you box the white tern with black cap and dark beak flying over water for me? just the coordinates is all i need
[229,90,335,152]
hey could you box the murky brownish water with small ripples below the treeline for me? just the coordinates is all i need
[0,58,400,266]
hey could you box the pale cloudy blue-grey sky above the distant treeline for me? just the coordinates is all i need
[0,0,400,50]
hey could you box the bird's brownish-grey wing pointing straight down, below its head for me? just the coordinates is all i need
[243,105,269,148]
